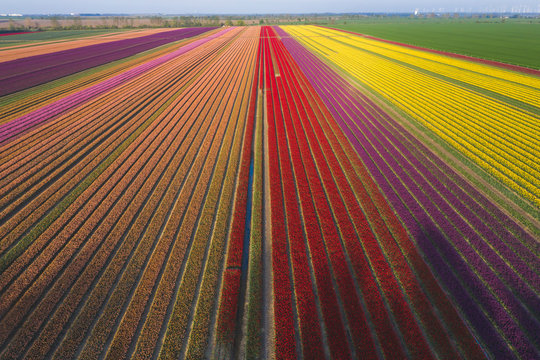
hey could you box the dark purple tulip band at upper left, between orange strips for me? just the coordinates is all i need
[0,27,214,96]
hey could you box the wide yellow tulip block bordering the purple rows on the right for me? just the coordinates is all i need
[285,27,540,206]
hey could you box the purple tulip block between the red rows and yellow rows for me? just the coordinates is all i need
[276,28,540,358]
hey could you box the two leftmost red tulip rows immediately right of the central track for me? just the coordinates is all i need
[262,27,324,358]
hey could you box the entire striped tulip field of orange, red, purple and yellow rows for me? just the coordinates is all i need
[0,25,540,359]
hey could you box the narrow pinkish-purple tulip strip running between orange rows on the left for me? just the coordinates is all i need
[0,28,232,145]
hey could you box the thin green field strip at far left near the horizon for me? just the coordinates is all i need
[0,29,130,47]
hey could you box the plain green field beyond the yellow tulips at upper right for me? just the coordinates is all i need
[328,18,540,69]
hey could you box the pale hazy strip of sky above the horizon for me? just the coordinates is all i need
[0,0,540,14]
